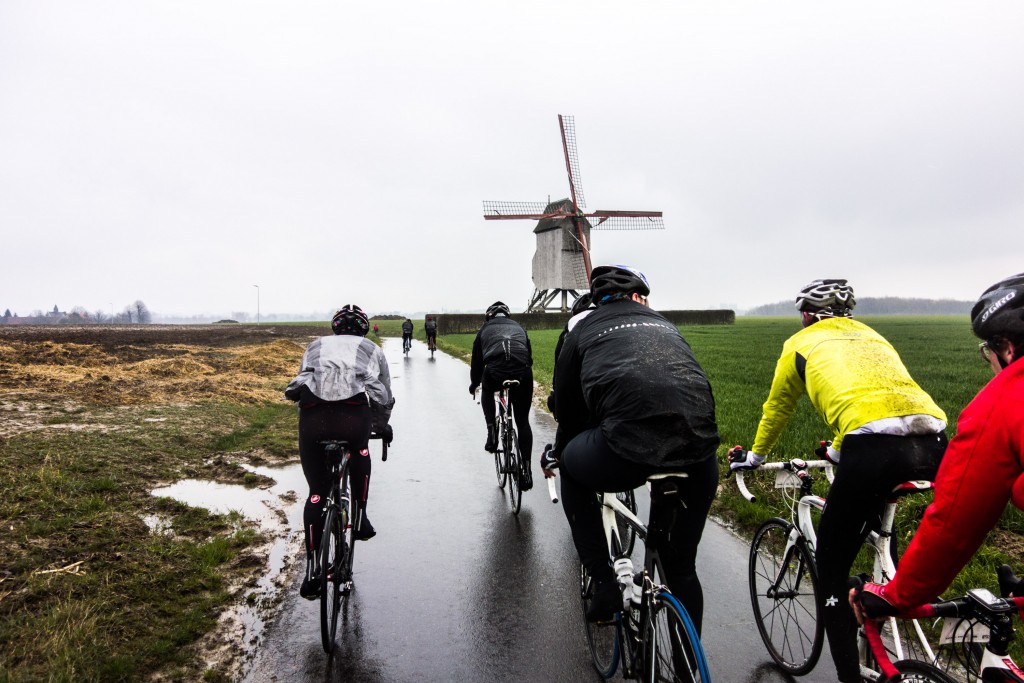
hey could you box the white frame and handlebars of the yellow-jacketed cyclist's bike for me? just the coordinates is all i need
[735,459,936,680]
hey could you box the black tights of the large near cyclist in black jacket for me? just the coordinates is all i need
[559,428,718,632]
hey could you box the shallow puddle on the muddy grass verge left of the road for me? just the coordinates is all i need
[145,463,306,666]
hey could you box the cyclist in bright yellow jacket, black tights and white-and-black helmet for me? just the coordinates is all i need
[729,280,946,683]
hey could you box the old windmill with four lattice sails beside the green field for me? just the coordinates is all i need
[483,114,665,312]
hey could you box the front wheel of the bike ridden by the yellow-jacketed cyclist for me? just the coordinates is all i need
[749,518,824,676]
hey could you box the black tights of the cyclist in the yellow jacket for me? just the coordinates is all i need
[815,433,946,681]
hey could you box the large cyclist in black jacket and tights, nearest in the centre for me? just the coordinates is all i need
[545,265,719,629]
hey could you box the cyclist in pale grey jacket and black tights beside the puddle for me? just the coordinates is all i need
[285,304,394,599]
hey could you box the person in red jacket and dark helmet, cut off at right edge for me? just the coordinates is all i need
[860,272,1024,617]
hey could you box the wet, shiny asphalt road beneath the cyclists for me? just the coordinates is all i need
[247,339,835,683]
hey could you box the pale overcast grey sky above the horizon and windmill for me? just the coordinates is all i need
[0,0,1024,315]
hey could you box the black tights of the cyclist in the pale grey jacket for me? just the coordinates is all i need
[299,402,371,552]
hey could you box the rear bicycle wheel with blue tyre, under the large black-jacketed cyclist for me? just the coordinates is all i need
[643,592,711,683]
